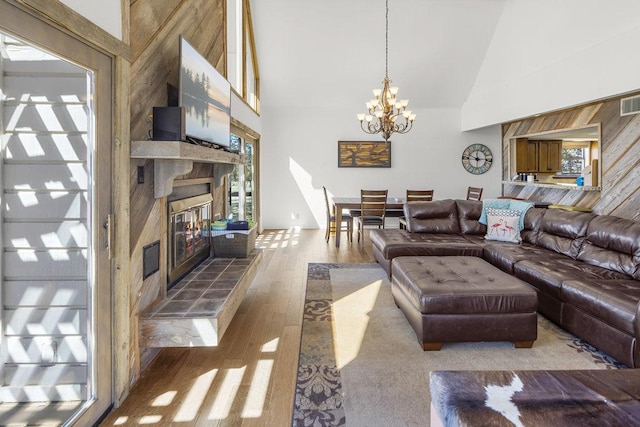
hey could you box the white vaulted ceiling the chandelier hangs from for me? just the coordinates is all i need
[251,0,506,110]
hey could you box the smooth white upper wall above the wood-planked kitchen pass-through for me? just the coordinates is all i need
[462,0,640,130]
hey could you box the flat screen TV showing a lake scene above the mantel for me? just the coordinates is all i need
[178,36,231,147]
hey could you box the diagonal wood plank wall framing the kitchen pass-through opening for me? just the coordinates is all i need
[502,95,640,220]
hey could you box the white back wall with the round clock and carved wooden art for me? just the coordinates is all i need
[261,107,501,228]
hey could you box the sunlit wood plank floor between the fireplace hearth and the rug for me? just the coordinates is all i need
[101,229,376,426]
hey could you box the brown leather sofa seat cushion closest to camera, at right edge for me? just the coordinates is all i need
[560,279,640,335]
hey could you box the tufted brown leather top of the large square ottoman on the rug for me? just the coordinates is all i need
[392,256,538,314]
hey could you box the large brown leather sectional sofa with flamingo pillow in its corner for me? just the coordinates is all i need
[371,200,640,367]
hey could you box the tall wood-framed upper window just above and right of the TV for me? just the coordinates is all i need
[227,0,260,112]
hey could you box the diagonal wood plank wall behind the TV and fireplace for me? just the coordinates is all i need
[129,0,226,383]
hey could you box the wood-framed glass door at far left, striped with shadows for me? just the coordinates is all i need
[0,2,112,425]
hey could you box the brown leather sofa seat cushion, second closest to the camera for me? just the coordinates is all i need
[513,253,629,299]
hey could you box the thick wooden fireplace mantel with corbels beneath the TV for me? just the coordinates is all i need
[131,141,247,199]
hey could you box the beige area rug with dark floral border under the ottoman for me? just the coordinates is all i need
[292,263,625,427]
